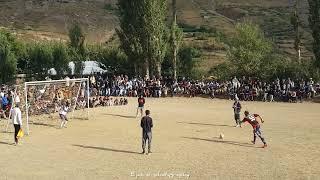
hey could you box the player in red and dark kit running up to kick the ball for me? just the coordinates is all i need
[241,111,267,148]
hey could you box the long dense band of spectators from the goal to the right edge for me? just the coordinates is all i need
[90,74,320,102]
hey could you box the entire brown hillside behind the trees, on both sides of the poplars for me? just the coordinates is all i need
[0,0,312,72]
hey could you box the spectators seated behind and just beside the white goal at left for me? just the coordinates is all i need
[0,79,128,119]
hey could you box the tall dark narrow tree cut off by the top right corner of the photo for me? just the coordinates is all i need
[308,0,320,68]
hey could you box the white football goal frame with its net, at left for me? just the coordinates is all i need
[21,78,90,134]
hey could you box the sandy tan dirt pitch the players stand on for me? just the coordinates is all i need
[0,98,320,180]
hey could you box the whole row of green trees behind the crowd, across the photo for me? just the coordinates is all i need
[0,0,320,83]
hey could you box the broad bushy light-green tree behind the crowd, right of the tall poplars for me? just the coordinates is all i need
[211,22,320,80]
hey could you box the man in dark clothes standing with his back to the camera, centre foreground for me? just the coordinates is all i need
[140,110,153,155]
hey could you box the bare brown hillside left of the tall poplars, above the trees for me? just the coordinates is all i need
[0,0,118,42]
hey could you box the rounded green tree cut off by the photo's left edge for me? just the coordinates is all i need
[0,32,17,83]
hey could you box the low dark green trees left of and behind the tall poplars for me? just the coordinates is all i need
[0,23,201,83]
